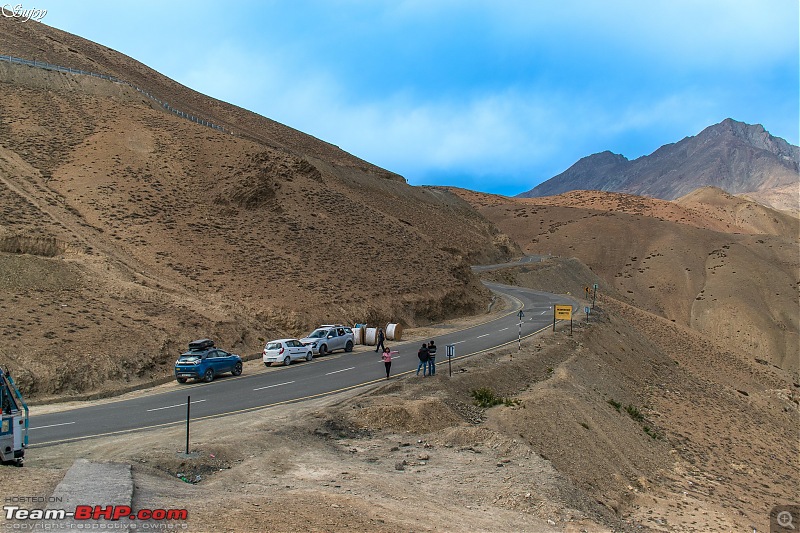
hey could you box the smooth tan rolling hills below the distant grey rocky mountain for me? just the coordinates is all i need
[456,189,800,372]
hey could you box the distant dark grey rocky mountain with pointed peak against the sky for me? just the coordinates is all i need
[519,119,800,215]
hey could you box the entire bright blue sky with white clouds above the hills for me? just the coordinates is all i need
[34,0,800,195]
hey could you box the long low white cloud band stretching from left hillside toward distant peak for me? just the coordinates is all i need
[179,38,764,186]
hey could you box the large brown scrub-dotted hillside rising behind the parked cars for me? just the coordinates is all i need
[0,18,516,397]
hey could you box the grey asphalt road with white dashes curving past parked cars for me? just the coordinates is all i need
[29,283,579,447]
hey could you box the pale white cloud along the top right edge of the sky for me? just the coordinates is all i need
[483,0,800,68]
